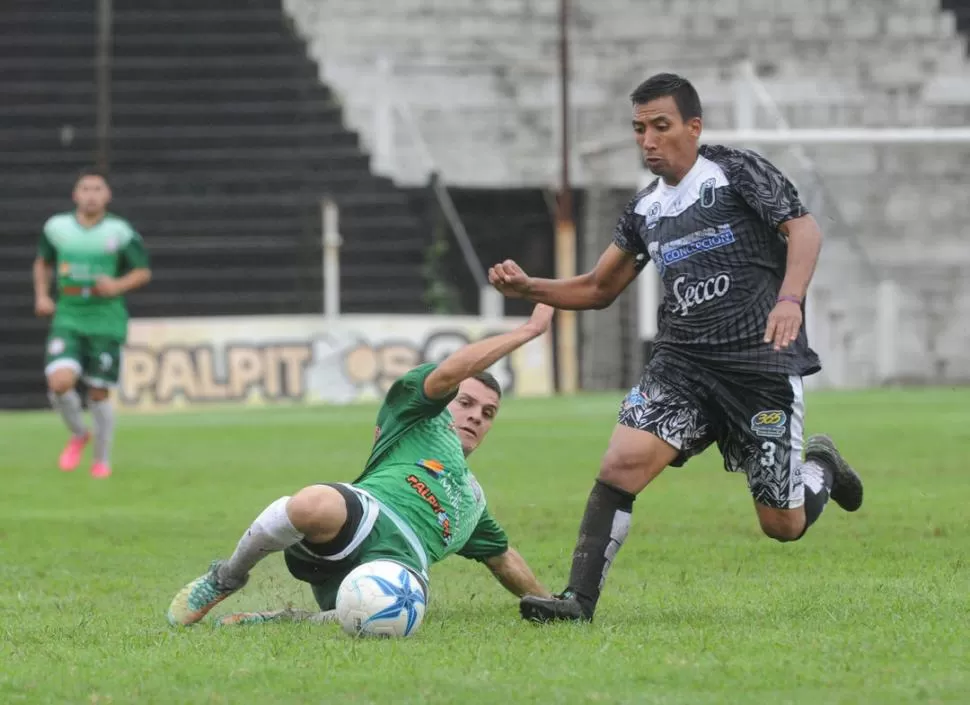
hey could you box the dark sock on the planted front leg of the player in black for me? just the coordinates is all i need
[568,480,636,616]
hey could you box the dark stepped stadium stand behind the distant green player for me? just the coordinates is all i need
[0,0,427,407]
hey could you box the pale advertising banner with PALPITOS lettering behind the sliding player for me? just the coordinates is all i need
[117,315,553,411]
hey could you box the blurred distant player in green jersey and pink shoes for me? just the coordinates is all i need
[34,170,151,477]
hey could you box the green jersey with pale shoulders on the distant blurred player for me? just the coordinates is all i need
[37,213,148,341]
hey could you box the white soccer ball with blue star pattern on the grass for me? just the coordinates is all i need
[337,560,427,637]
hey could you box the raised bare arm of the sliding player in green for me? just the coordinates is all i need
[424,304,555,399]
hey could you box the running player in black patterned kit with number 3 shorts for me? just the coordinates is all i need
[489,74,862,622]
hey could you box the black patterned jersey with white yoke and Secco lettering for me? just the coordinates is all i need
[613,145,821,375]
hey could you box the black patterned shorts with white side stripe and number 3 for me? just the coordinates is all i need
[619,353,805,509]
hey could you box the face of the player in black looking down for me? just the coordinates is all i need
[633,96,701,185]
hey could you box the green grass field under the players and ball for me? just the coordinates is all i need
[0,390,970,705]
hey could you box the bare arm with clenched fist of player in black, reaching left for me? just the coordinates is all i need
[488,244,637,311]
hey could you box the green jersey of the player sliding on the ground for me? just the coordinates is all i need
[354,364,508,563]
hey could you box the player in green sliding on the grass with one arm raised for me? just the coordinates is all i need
[168,304,553,625]
